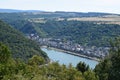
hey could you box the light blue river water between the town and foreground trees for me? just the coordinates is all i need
[41,48,98,69]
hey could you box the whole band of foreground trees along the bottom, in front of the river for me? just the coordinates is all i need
[0,38,120,80]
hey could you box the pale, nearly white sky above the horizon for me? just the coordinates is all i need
[0,0,120,14]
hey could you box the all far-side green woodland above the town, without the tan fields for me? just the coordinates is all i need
[0,12,120,47]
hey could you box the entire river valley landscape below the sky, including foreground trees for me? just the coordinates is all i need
[0,9,120,80]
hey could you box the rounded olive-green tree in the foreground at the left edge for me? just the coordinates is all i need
[0,43,15,79]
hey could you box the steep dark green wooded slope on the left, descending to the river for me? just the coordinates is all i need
[0,20,48,61]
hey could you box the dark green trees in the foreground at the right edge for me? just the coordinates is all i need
[95,37,120,80]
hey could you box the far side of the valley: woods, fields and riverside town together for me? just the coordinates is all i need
[0,11,120,58]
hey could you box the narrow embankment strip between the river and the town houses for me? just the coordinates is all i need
[41,46,100,62]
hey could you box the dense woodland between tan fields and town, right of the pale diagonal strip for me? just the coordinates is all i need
[39,20,120,46]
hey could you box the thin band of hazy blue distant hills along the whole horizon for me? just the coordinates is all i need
[0,9,117,17]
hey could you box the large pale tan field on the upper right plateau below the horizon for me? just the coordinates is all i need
[67,15,120,24]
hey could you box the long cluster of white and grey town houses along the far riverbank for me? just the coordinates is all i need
[28,34,109,58]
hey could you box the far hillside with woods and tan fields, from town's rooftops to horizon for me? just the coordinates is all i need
[0,11,120,47]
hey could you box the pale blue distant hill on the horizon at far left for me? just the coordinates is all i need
[0,9,43,13]
